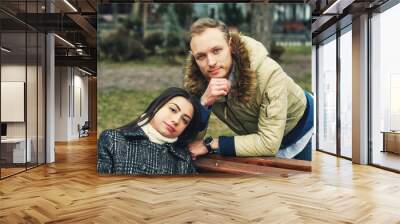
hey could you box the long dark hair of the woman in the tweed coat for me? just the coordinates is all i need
[120,87,201,145]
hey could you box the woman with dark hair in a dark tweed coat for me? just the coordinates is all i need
[97,87,201,175]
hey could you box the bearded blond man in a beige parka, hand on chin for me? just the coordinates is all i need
[184,18,313,160]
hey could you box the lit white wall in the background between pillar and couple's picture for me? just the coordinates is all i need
[55,67,88,141]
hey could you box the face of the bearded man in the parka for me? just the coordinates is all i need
[190,28,232,80]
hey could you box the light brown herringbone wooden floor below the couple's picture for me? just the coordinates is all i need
[0,134,400,224]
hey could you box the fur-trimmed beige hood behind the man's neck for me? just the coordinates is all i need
[184,33,268,103]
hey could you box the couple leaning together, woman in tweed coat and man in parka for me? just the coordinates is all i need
[97,18,313,174]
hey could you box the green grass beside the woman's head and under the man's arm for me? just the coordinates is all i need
[97,90,233,137]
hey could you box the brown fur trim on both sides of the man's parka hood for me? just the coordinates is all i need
[184,33,257,102]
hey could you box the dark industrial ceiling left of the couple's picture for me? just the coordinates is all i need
[0,0,97,74]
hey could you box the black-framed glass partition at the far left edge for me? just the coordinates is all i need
[0,1,46,178]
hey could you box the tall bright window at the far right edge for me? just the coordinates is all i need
[370,4,400,170]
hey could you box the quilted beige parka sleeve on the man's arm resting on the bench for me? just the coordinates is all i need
[234,57,288,156]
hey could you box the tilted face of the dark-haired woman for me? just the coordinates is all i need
[150,96,193,138]
